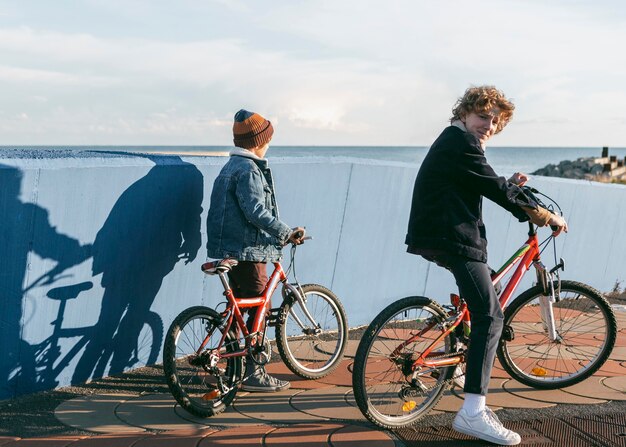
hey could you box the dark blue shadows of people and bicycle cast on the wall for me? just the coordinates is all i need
[0,156,203,398]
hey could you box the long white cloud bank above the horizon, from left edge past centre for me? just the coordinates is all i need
[0,24,448,144]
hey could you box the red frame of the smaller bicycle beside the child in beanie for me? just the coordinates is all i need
[196,262,287,358]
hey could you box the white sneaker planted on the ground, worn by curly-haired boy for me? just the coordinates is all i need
[452,408,522,445]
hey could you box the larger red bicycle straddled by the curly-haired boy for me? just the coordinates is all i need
[352,187,617,428]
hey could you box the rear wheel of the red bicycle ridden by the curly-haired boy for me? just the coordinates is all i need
[352,296,456,429]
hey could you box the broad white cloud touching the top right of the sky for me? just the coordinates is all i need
[252,0,626,74]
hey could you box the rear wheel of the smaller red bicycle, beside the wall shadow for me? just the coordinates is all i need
[163,306,243,417]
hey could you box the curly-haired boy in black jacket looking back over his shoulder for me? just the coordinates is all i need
[405,86,567,445]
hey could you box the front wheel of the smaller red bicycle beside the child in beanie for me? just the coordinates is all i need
[276,284,348,379]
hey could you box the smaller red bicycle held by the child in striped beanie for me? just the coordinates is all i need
[163,237,348,417]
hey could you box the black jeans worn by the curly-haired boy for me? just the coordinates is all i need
[424,254,504,396]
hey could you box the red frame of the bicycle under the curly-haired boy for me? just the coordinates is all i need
[404,222,544,371]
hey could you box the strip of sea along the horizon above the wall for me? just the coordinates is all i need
[0,146,626,176]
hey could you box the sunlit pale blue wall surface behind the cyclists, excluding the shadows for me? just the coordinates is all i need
[0,152,626,393]
